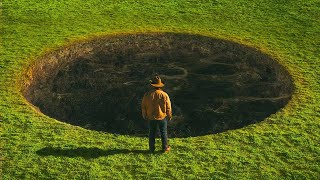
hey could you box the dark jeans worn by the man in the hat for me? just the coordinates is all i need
[149,117,168,151]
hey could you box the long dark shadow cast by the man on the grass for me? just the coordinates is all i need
[36,147,161,158]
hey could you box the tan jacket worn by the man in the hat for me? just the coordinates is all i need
[141,89,172,120]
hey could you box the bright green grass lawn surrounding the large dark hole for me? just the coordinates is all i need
[0,0,320,179]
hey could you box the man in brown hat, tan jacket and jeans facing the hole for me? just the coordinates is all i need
[141,76,172,152]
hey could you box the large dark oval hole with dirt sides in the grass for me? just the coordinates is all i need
[23,33,294,137]
